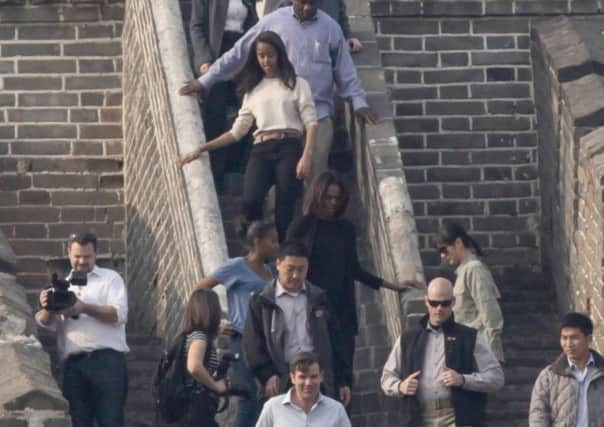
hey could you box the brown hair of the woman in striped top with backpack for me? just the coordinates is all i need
[182,289,222,339]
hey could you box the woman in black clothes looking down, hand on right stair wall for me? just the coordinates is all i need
[287,172,420,404]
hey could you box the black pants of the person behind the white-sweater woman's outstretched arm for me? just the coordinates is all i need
[203,31,249,182]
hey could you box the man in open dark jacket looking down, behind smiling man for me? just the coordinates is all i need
[242,242,351,405]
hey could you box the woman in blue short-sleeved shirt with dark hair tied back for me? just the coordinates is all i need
[197,221,279,427]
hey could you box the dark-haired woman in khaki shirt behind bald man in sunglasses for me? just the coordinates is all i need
[434,223,505,362]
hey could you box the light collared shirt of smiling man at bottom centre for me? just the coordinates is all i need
[256,388,350,427]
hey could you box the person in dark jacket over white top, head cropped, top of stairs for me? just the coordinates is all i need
[189,0,258,182]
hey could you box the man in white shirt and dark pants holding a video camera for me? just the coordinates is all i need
[36,233,129,427]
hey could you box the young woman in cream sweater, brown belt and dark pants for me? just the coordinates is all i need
[181,31,317,241]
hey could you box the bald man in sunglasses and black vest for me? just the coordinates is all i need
[381,277,504,427]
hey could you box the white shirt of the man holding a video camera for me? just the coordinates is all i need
[36,266,129,360]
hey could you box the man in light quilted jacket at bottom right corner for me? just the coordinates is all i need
[529,313,604,427]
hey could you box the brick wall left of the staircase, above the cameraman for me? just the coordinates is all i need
[0,0,124,289]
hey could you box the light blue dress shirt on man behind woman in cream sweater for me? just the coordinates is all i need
[199,6,367,120]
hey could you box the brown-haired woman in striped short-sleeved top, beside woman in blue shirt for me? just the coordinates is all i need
[180,289,227,427]
